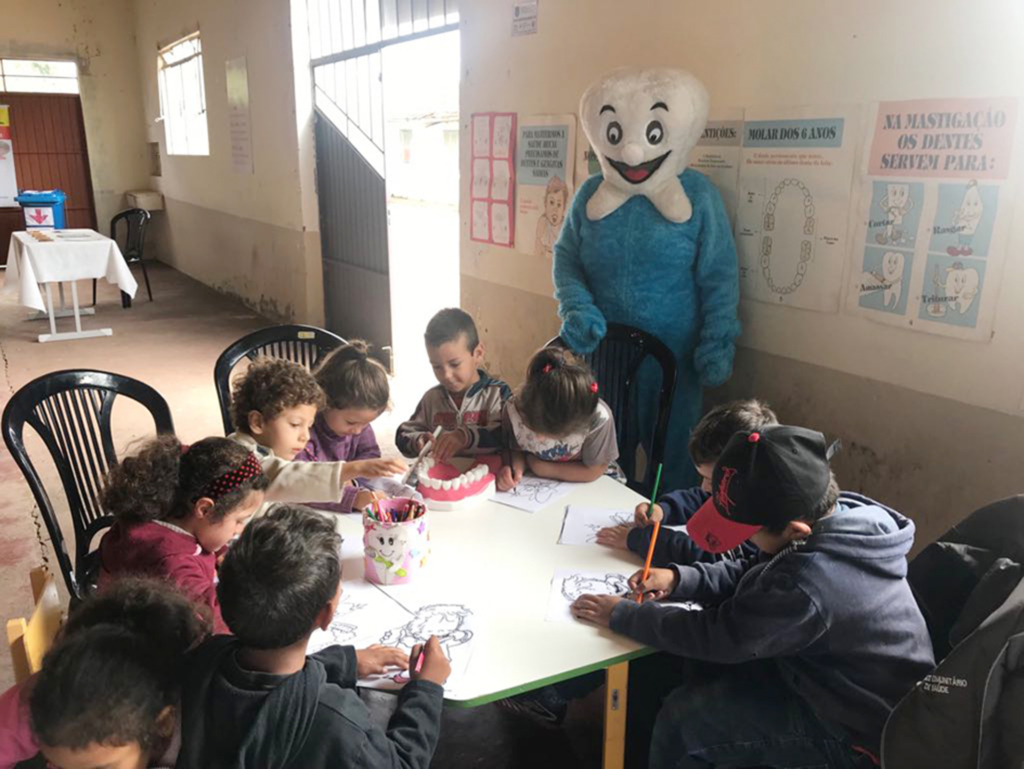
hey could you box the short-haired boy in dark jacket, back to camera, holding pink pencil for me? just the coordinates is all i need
[177,505,451,769]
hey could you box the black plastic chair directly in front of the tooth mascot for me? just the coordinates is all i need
[548,324,676,496]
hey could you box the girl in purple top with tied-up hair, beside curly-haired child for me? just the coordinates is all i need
[295,339,415,513]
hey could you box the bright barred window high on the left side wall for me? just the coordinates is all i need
[157,32,210,155]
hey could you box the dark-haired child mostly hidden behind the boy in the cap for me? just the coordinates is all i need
[597,399,778,566]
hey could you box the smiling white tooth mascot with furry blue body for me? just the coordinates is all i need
[554,69,739,489]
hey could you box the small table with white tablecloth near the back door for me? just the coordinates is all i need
[0,229,138,342]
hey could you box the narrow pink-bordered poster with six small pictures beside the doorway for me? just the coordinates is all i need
[469,113,516,248]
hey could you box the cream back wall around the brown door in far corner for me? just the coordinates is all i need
[0,0,148,231]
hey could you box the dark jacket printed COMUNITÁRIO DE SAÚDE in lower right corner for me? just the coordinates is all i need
[881,496,1024,769]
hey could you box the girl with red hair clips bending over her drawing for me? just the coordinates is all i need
[498,347,618,492]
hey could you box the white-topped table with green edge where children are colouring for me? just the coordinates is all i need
[337,477,651,769]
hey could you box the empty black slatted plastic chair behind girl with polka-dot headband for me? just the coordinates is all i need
[2,371,174,601]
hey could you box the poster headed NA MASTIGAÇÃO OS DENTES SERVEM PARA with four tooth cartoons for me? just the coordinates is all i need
[848,98,1017,339]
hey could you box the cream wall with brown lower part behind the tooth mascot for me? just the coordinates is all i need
[461,0,1024,548]
